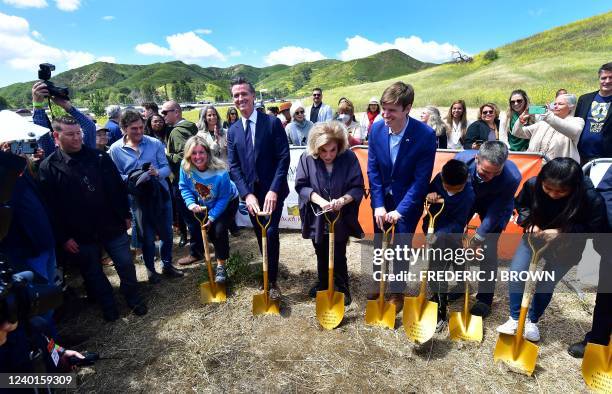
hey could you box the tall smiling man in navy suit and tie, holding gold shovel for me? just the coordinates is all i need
[227,77,290,299]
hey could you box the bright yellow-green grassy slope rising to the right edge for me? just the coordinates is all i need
[325,12,612,113]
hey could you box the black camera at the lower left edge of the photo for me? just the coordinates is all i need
[0,255,63,323]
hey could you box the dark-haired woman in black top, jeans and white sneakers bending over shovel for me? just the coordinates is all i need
[497,157,607,342]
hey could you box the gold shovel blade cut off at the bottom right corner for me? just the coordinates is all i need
[582,336,612,393]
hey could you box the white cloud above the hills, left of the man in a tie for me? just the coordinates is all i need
[135,31,225,61]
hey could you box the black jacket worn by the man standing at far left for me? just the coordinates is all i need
[39,145,130,245]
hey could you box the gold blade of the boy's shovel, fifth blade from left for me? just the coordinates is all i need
[402,297,438,343]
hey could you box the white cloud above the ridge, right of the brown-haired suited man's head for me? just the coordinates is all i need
[340,35,465,63]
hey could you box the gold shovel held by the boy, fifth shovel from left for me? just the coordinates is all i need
[402,199,444,343]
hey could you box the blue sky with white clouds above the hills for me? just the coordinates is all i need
[0,0,610,86]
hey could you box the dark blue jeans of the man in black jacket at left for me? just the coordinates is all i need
[69,233,142,311]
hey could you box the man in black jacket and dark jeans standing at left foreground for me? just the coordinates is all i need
[39,116,147,321]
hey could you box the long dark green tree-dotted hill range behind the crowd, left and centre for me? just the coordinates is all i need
[0,50,430,109]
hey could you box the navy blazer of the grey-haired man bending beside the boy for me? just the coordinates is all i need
[455,150,522,237]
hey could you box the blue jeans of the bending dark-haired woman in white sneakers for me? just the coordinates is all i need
[508,239,578,323]
